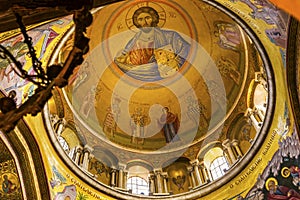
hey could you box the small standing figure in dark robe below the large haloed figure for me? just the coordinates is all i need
[158,107,180,143]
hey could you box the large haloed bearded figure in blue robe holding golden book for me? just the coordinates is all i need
[115,6,190,81]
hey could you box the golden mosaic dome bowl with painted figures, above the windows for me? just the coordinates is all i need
[56,2,263,151]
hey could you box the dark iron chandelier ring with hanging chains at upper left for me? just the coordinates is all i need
[0,4,93,133]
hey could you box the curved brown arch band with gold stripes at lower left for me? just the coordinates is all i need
[0,87,51,200]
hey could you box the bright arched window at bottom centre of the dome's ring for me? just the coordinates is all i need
[127,176,149,195]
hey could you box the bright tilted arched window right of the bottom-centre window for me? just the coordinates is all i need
[210,156,229,180]
